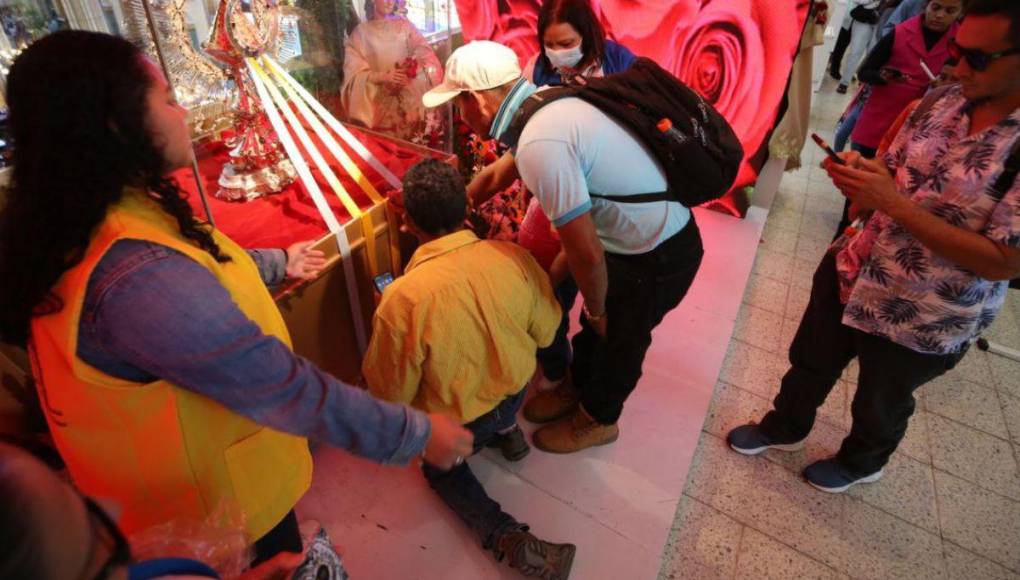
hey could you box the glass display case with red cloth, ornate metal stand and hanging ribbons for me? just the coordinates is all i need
[0,0,459,379]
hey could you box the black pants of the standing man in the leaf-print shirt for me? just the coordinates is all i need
[761,253,966,475]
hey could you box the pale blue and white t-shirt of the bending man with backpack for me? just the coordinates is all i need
[514,98,691,254]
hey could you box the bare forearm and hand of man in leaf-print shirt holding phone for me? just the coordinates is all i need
[826,154,1020,280]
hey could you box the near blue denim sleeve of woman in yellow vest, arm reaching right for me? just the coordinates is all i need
[78,241,430,464]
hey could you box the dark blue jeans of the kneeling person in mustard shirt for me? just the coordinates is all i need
[421,389,527,558]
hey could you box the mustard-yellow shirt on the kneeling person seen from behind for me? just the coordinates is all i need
[362,230,560,423]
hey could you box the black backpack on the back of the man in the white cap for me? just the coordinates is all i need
[501,58,744,207]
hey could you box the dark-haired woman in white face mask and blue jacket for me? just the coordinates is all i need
[524,0,634,87]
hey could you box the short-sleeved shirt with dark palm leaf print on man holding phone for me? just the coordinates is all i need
[836,87,1020,355]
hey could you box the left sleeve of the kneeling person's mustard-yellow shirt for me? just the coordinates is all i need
[361,306,424,405]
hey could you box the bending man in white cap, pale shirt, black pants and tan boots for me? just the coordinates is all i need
[422,41,704,453]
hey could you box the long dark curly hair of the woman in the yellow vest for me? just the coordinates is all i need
[0,31,228,345]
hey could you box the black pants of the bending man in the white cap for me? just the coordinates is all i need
[570,215,704,425]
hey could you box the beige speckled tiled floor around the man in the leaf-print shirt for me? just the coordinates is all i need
[660,85,1020,580]
